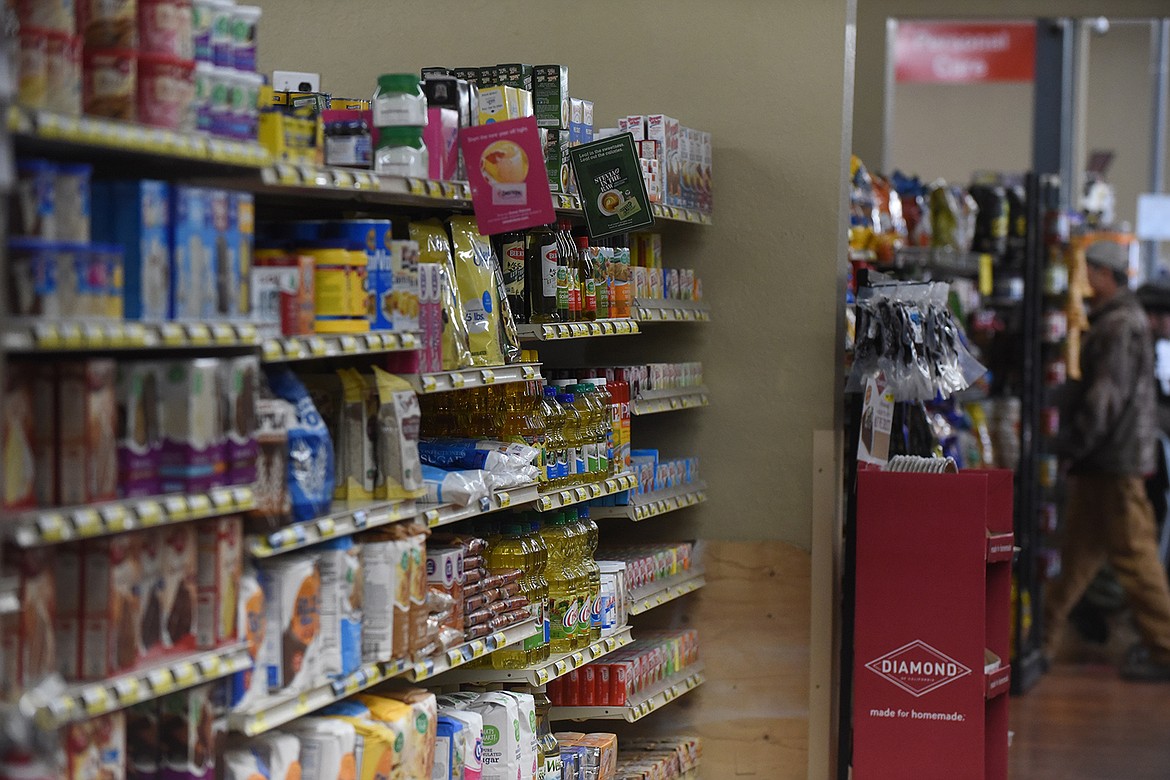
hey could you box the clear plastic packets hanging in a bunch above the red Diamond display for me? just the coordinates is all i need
[846,282,986,401]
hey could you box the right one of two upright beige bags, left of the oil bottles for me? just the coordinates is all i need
[373,366,426,501]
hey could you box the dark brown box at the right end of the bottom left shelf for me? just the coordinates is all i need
[158,685,215,780]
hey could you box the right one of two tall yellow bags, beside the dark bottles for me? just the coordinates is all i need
[443,216,504,367]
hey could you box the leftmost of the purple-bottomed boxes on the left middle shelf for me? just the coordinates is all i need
[117,360,163,498]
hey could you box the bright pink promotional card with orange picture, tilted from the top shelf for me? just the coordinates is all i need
[460,117,557,235]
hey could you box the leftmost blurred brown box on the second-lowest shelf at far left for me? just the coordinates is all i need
[0,545,57,693]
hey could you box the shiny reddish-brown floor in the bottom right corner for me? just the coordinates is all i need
[1010,665,1170,780]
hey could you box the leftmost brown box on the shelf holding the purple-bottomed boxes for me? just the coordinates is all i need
[0,364,37,511]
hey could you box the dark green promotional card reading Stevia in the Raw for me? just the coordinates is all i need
[569,133,654,239]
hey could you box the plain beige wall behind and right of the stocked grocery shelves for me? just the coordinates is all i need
[260,0,847,548]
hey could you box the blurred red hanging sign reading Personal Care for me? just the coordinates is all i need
[894,21,1035,84]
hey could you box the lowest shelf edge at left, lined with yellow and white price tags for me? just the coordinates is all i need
[29,642,252,730]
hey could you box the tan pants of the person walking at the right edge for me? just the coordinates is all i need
[1044,475,1170,663]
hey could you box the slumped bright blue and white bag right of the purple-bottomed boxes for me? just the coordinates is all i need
[266,367,333,522]
